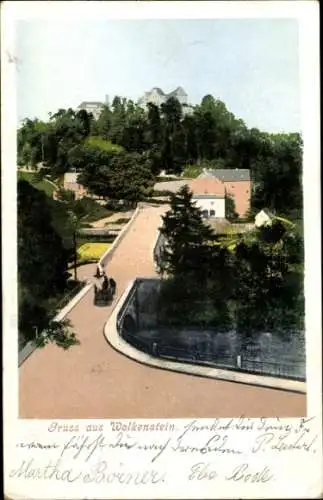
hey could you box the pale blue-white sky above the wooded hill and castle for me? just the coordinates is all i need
[16,18,300,132]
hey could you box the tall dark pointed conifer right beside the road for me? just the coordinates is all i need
[159,187,238,331]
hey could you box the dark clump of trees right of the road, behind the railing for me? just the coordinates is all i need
[159,188,304,336]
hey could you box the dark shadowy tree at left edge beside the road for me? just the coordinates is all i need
[18,181,70,344]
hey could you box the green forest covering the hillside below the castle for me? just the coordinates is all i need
[18,95,302,218]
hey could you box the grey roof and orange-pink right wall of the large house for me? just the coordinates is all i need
[198,168,252,217]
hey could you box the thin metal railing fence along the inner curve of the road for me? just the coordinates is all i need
[117,279,306,381]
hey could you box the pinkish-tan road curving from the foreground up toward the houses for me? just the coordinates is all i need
[19,206,306,419]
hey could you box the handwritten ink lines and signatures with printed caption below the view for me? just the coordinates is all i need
[8,417,319,486]
